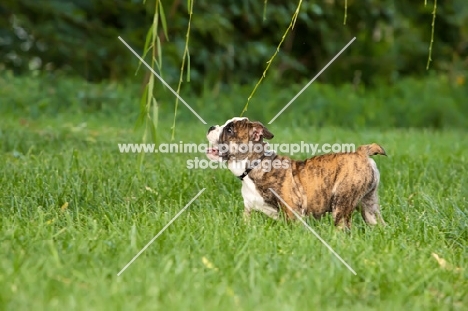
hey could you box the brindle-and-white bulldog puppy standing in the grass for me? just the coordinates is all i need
[207,118,386,228]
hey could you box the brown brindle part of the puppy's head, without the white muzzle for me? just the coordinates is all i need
[218,118,273,160]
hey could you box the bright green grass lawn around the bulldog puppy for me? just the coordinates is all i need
[0,111,468,310]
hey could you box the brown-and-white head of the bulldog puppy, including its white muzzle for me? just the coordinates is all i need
[207,118,274,161]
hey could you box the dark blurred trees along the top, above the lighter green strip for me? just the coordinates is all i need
[0,0,468,88]
